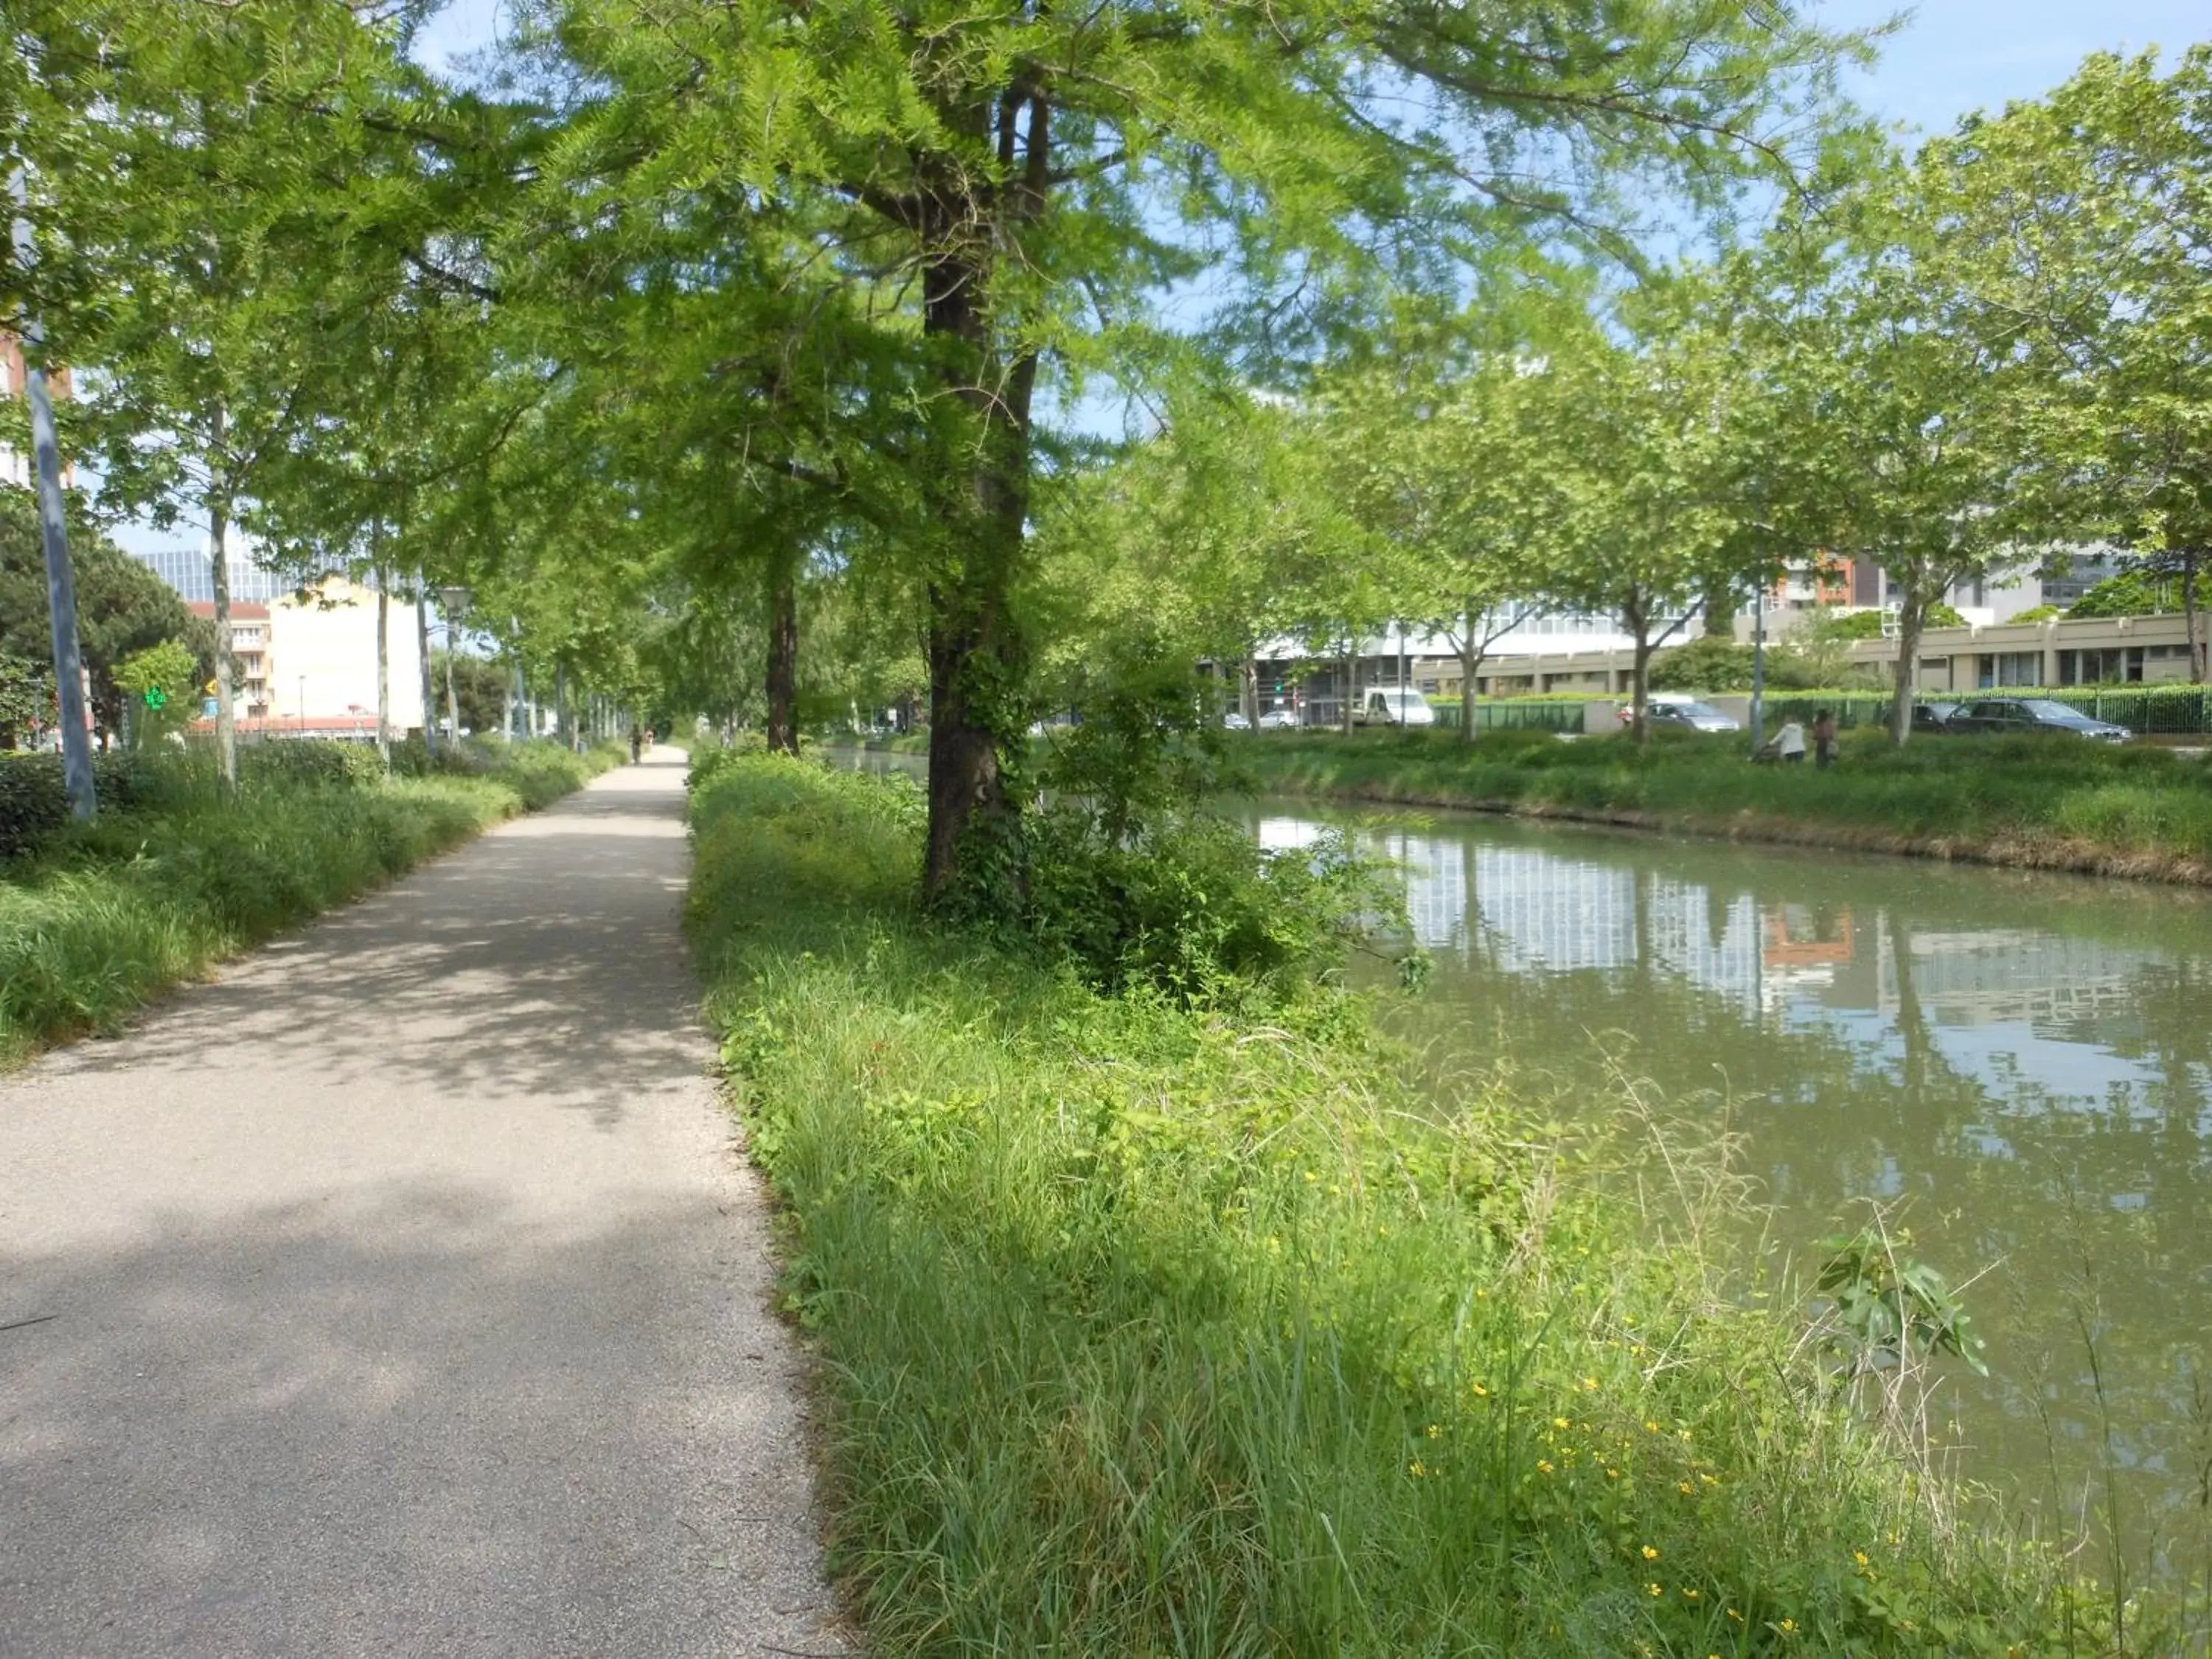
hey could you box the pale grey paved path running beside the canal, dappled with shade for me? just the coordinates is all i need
[0,750,845,1659]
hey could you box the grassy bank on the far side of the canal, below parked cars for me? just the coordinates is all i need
[1237,732,2212,883]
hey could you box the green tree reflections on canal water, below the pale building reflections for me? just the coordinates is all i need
[1409,889,2212,1593]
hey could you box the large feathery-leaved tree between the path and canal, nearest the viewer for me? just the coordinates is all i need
[518,0,1845,900]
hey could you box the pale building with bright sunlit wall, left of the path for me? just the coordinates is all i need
[192,577,422,739]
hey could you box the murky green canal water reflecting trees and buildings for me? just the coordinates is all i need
[1252,805,2212,1573]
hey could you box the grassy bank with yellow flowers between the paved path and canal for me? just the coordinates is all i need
[688,757,2110,1657]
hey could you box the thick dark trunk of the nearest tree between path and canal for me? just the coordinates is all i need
[920,91,1051,907]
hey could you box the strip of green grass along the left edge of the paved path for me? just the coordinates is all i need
[0,743,613,1066]
